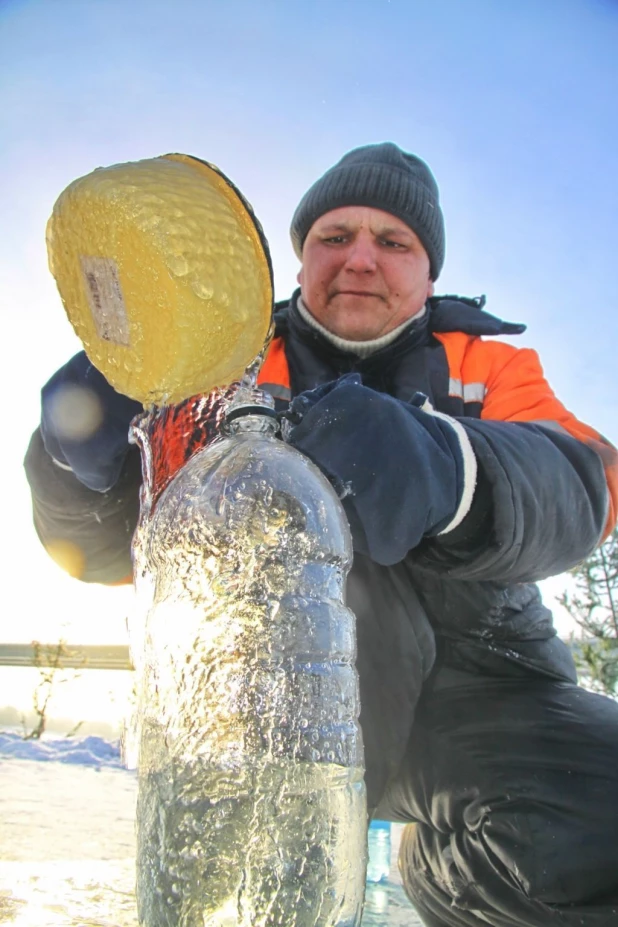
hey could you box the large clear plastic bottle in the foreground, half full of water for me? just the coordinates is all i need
[131,391,367,927]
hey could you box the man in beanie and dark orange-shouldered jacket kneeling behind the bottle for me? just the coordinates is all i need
[26,143,618,927]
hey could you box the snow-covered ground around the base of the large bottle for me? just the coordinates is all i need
[0,732,420,927]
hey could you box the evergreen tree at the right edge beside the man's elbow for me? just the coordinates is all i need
[558,529,618,698]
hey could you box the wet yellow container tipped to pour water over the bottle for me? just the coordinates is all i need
[47,154,273,406]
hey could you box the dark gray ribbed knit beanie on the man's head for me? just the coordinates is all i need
[290,142,445,280]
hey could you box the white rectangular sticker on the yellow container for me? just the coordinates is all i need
[80,254,130,345]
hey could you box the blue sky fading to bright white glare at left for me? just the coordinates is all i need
[0,0,618,639]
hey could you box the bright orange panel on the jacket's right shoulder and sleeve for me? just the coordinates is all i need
[435,332,618,540]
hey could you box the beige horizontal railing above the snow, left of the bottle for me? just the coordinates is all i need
[0,642,133,670]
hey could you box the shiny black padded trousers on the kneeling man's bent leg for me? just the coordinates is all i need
[379,679,618,927]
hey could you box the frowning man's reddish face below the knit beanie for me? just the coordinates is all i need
[298,206,433,341]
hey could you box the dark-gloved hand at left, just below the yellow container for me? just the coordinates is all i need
[41,351,142,492]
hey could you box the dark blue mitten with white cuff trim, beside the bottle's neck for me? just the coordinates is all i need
[285,374,477,565]
